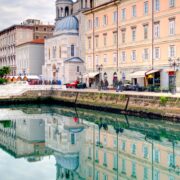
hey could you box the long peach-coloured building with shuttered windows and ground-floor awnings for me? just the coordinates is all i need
[84,0,180,90]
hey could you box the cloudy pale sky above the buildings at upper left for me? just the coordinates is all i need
[0,0,55,30]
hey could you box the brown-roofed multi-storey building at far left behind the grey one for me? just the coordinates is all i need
[0,20,54,76]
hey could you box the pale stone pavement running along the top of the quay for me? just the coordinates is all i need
[0,84,180,98]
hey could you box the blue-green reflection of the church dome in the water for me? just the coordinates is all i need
[55,153,79,171]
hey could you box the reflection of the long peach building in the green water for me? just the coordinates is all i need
[86,124,180,180]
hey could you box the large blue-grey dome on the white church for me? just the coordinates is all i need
[55,16,79,32]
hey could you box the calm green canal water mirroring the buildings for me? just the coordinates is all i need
[0,106,180,180]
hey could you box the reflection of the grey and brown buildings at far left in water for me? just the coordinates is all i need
[0,112,49,162]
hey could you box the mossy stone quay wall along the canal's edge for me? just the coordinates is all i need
[0,90,180,122]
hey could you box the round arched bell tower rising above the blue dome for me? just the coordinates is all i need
[56,0,73,21]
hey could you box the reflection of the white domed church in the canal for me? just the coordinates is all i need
[46,115,85,180]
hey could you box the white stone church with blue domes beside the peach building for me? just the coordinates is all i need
[43,0,94,83]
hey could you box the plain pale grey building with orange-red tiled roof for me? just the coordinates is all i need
[16,39,44,76]
